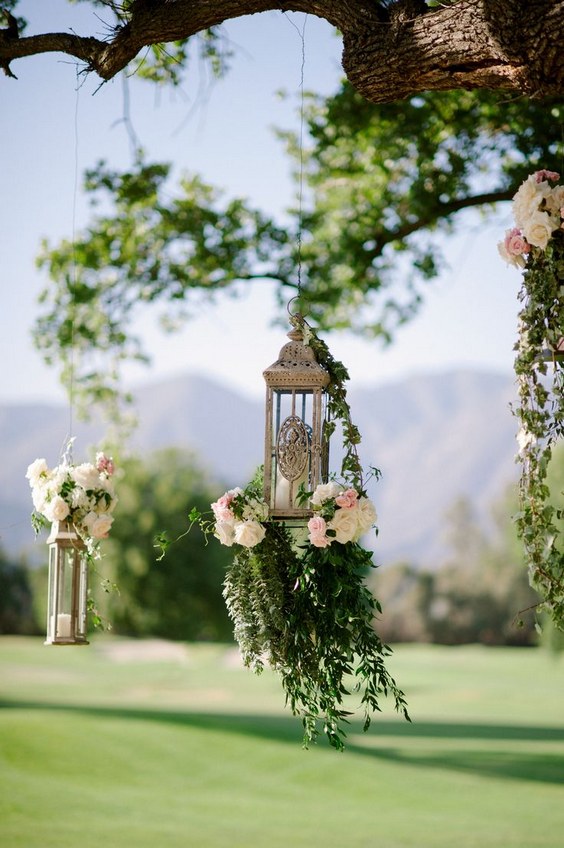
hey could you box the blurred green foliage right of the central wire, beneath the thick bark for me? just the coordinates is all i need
[286,85,564,340]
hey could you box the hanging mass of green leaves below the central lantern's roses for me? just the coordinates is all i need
[224,522,409,750]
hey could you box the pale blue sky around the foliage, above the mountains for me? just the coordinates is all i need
[0,0,520,403]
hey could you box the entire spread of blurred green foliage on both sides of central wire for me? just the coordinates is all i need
[35,85,563,414]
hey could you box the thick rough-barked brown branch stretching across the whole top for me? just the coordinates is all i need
[0,0,564,103]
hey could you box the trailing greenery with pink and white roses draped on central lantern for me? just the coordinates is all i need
[181,316,409,750]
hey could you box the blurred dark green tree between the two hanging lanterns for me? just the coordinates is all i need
[99,449,232,641]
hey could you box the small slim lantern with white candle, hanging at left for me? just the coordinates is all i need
[45,521,88,645]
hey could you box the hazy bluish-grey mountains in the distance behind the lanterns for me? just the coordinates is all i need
[0,371,517,565]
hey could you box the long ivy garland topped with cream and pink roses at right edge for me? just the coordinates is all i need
[498,170,564,629]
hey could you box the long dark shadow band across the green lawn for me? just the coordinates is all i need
[0,700,564,784]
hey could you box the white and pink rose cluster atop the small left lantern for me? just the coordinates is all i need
[26,453,117,555]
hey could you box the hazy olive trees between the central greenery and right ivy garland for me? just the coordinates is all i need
[371,486,540,646]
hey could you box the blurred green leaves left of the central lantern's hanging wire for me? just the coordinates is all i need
[34,160,287,410]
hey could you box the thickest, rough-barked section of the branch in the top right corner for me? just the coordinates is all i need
[343,0,564,103]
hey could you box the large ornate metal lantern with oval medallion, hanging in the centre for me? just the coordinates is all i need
[263,322,329,520]
